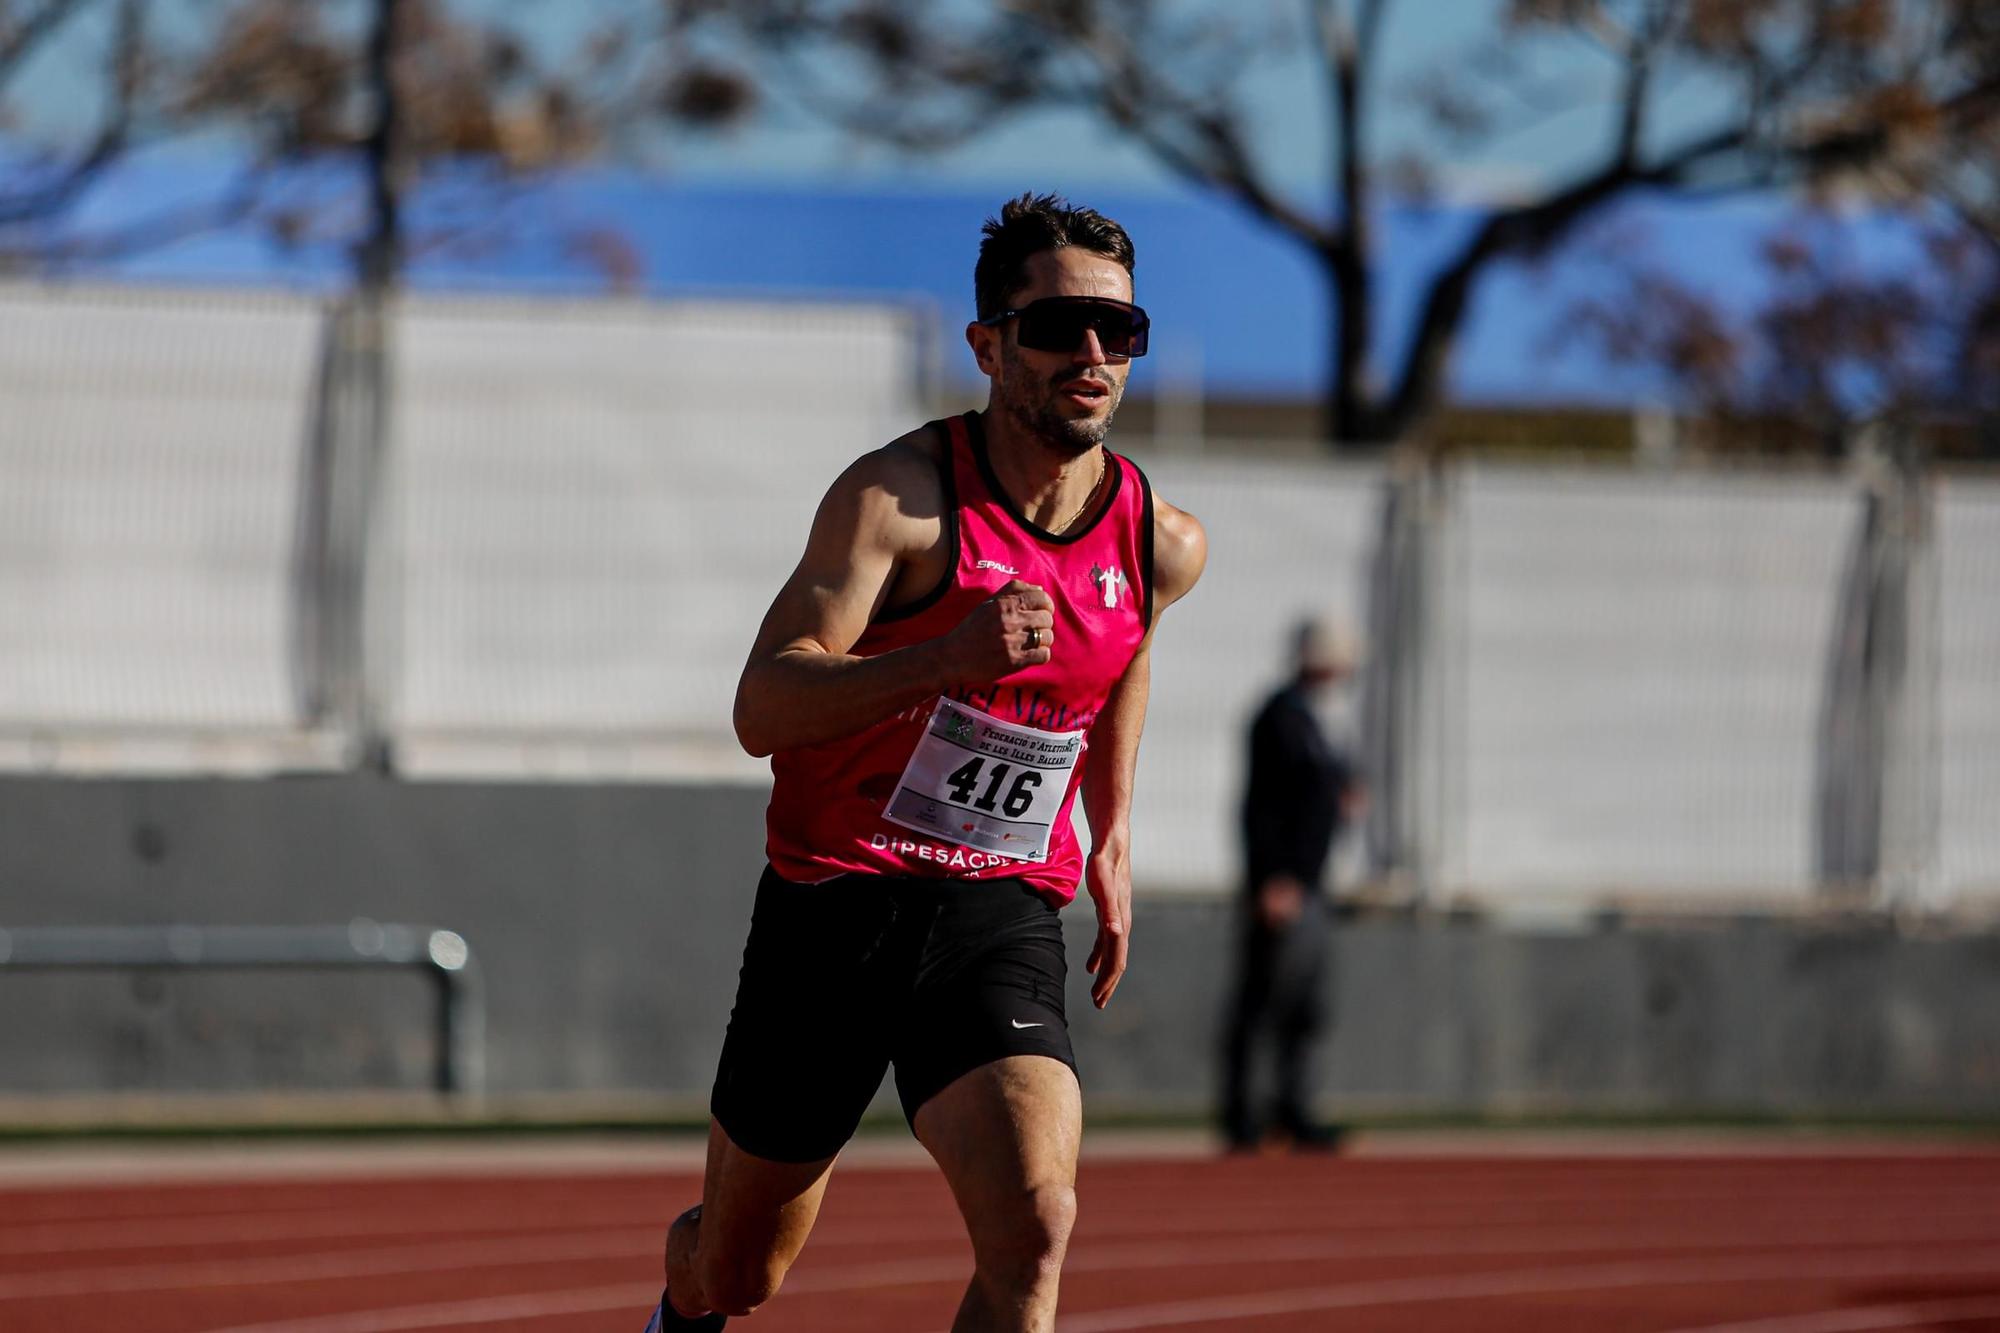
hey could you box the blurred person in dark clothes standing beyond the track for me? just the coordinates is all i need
[1222,620,1362,1151]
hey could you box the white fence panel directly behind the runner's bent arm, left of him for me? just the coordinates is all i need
[394,302,922,779]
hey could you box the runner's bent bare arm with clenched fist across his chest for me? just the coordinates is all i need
[734,434,1054,757]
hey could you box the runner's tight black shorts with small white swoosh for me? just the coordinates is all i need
[710,867,1076,1161]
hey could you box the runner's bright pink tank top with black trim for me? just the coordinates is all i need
[766,412,1152,903]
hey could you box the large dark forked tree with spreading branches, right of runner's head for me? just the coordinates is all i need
[652,0,2000,440]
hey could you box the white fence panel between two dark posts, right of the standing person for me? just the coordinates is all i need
[1448,466,1858,901]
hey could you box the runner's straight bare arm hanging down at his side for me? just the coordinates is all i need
[1084,496,1208,1009]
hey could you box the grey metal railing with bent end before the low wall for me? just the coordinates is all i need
[0,917,486,1101]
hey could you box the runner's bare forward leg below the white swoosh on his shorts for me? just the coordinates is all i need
[914,1055,1084,1333]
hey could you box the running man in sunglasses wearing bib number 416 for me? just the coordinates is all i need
[648,194,1208,1333]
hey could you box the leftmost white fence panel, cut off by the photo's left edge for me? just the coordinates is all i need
[0,286,320,767]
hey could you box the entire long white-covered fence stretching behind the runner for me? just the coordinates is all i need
[0,286,2000,909]
